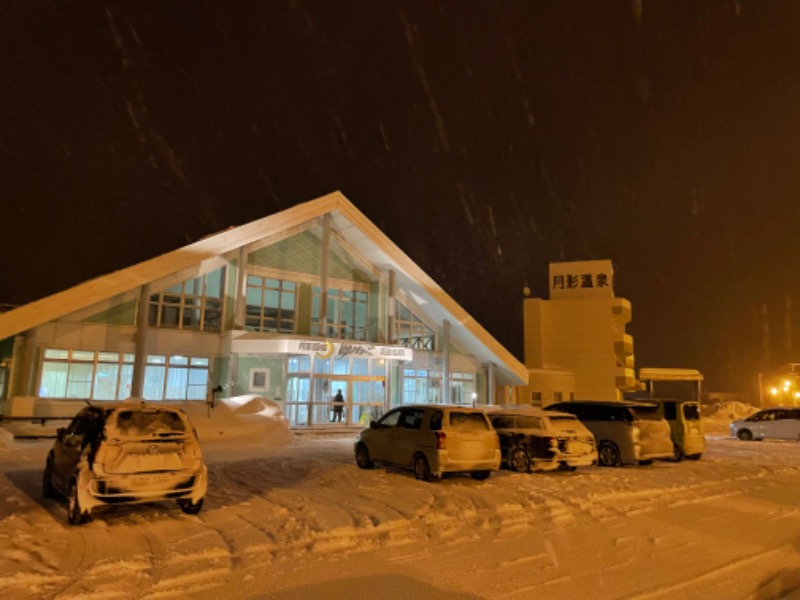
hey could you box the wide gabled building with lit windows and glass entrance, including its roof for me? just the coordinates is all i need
[0,192,527,427]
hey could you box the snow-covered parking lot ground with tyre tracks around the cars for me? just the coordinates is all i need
[0,402,800,600]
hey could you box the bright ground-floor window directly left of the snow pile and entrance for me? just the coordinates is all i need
[142,355,210,400]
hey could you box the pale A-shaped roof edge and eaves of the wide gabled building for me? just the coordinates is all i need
[0,192,528,385]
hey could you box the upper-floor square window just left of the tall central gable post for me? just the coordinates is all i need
[245,275,297,333]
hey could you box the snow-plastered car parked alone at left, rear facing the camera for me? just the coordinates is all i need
[42,401,208,525]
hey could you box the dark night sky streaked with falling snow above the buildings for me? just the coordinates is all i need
[0,0,800,394]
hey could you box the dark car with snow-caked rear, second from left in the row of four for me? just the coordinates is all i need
[484,405,597,473]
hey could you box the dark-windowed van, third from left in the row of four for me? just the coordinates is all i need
[546,400,673,467]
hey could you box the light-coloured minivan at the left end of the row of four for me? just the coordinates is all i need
[354,404,500,481]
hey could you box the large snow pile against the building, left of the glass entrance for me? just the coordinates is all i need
[180,395,294,446]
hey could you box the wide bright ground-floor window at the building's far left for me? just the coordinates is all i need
[39,348,133,400]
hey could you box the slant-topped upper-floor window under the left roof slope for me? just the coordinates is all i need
[148,267,225,331]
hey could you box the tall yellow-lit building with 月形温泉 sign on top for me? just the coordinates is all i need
[518,260,636,406]
